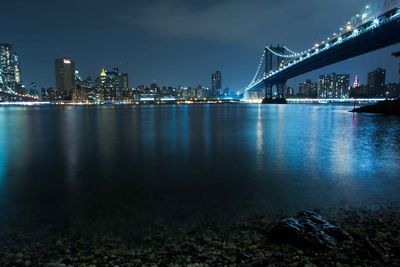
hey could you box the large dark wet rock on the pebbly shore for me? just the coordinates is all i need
[269,211,351,249]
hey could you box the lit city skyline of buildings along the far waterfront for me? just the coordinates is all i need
[0,43,399,102]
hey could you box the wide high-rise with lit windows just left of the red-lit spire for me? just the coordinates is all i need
[318,73,350,99]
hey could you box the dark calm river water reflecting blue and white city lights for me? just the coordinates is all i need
[0,105,400,234]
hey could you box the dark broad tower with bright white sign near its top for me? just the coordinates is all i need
[54,57,76,99]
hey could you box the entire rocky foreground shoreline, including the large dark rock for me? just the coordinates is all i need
[0,206,400,267]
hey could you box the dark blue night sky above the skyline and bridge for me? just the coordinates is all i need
[0,0,400,89]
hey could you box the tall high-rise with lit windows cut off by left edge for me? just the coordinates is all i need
[0,44,23,92]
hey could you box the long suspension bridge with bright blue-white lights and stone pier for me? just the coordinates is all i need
[238,0,400,103]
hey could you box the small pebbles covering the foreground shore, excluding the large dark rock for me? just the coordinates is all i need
[0,208,400,267]
